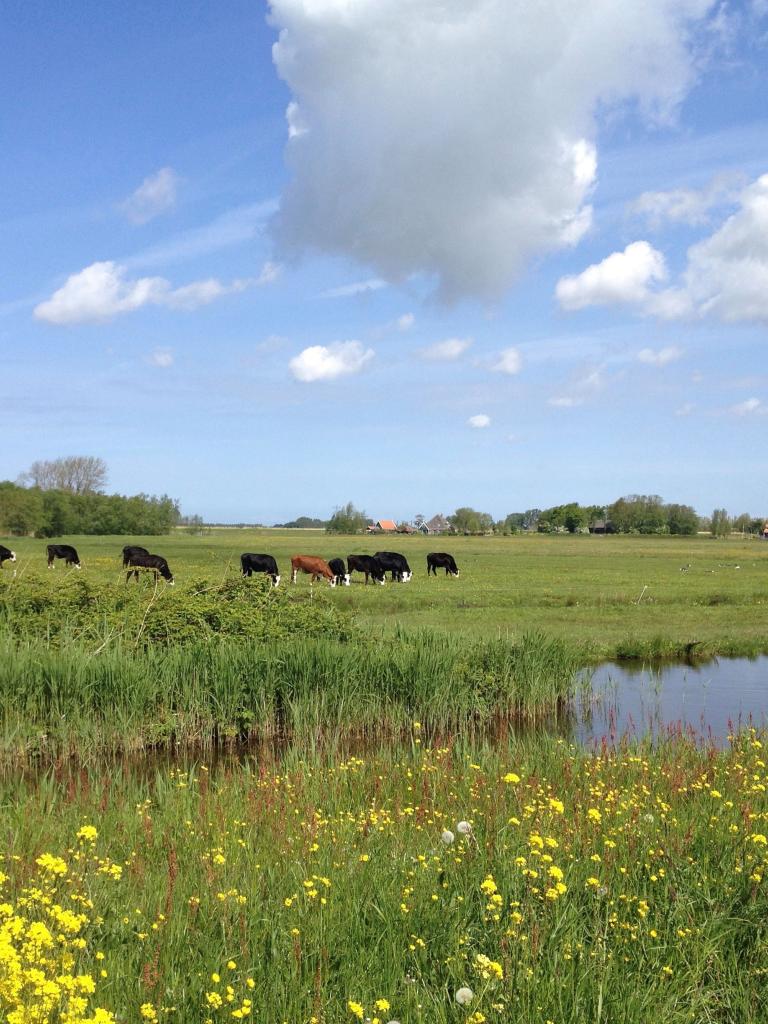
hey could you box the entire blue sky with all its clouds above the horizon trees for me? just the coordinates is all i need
[0,0,768,523]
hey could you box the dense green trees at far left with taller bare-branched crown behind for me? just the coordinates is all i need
[0,456,180,537]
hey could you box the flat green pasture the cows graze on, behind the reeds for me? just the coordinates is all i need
[3,528,768,659]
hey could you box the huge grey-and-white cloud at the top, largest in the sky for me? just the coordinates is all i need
[270,0,713,300]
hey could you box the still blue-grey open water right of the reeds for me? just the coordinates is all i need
[571,657,768,746]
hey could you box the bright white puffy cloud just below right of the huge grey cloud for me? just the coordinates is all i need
[555,242,667,310]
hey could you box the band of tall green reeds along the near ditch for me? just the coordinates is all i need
[0,634,578,761]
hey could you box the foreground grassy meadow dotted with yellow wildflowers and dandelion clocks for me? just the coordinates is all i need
[0,723,768,1024]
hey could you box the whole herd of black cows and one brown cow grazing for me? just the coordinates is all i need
[0,544,459,587]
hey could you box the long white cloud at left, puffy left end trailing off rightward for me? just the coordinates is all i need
[35,260,272,324]
